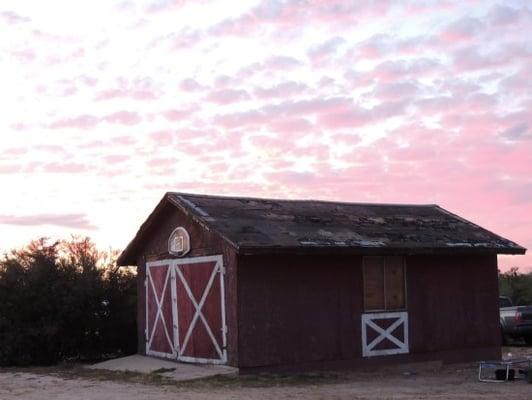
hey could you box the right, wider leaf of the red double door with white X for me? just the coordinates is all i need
[175,256,227,364]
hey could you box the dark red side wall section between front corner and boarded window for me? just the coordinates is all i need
[238,255,362,368]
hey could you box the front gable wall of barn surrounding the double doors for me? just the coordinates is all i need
[137,206,238,365]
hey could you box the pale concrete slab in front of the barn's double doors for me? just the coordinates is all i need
[87,354,238,381]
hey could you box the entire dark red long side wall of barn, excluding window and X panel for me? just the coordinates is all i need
[238,255,500,371]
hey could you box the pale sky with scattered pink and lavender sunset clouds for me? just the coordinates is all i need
[0,0,532,271]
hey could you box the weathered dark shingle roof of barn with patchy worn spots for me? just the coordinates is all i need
[118,192,526,265]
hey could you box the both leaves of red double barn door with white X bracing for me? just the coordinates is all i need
[145,256,227,364]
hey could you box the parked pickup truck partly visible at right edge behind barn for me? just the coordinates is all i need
[499,296,532,345]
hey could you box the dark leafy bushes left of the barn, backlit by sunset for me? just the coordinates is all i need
[0,238,136,365]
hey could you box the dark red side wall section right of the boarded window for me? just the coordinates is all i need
[407,256,501,356]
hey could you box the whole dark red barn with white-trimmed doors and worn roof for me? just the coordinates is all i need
[118,193,526,372]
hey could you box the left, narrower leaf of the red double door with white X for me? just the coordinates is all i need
[144,261,176,359]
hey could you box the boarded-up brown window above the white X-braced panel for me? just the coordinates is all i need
[363,257,405,311]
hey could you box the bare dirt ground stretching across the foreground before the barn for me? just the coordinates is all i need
[0,346,532,400]
